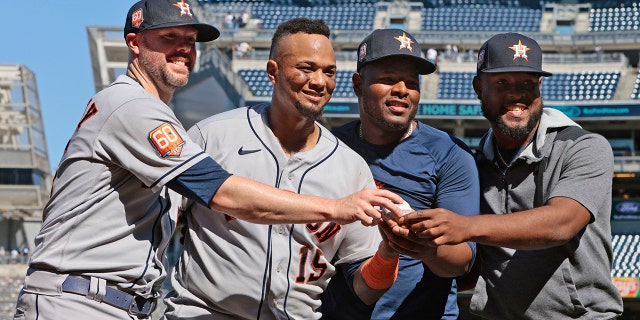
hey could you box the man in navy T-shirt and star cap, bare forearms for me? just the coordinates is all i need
[322,29,480,320]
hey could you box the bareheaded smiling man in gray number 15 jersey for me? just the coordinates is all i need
[165,18,402,319]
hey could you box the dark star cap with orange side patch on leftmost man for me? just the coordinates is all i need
[124,0,220,42]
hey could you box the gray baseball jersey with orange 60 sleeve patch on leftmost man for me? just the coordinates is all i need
[30,76,207,297]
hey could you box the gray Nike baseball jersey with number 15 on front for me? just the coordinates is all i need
[167,105,381,319]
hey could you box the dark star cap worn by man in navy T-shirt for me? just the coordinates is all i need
[357,29,436,74]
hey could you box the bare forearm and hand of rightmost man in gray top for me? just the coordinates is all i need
[394,197,591,250]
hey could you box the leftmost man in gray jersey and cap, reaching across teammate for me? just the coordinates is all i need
[14,0,402,320]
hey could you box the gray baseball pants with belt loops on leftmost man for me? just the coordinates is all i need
[13,271,150,320]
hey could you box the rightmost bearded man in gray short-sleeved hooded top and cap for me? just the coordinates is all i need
[394,33,623,319]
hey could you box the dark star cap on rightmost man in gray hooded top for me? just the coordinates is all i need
[476,33,551,77]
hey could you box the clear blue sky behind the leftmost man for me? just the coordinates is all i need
[0,0,135,172]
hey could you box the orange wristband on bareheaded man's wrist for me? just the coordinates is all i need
[360,252,400,290]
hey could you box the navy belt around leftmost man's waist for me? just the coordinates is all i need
[62,276,157,316]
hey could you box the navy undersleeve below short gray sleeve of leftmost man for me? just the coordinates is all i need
[167,157,231,207]
